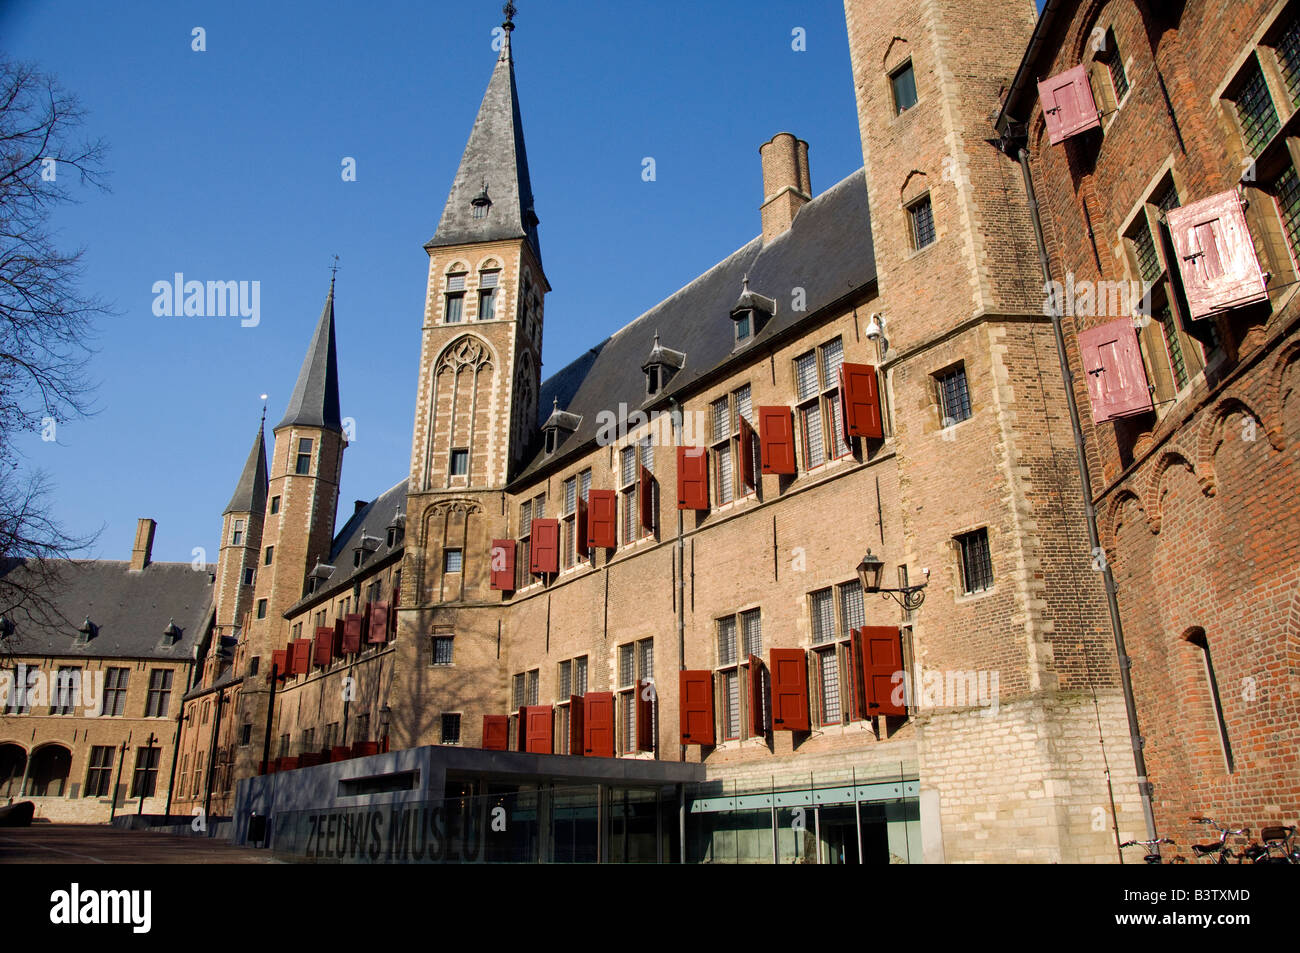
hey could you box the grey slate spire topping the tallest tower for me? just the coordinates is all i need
[425,4,542,261]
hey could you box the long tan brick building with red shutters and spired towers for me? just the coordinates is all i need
[181,0,1170,862]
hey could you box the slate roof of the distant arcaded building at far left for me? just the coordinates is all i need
[0,559,215,660]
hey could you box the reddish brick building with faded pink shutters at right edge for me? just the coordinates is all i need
[998,0,1300,844]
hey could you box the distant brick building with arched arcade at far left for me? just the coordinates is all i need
[0,520,213,823]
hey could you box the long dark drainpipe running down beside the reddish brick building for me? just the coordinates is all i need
[1015,148,1160,854]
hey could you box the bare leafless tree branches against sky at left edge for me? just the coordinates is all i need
[0,57,111,653]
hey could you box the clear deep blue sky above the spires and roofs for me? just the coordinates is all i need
[0,0,1029,560]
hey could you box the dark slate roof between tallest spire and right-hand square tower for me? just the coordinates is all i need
[512,169,876,484]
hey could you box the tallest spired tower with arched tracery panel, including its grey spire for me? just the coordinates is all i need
[391,4,550,746]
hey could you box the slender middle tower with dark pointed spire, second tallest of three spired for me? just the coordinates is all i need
[237,280,347,776]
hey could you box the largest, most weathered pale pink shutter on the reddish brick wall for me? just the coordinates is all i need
[1166,190,1269,317]
